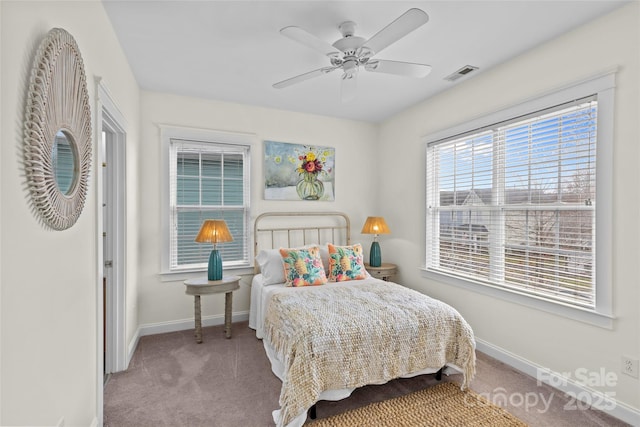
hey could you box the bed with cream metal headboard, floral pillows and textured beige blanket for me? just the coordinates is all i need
[249,212,475,427]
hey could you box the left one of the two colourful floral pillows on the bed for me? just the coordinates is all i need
[280,246,327,287]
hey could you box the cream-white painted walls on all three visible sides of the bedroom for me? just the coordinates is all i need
[0,0,640,425]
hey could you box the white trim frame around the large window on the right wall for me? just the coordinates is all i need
[422,70,616,329]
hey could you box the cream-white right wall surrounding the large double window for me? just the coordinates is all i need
[378,2,640,411]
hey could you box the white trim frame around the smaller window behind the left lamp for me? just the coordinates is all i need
[160,125,257,280]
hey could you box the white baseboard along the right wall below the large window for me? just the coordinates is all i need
[476,338,640,425]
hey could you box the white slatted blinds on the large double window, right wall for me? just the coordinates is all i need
[426,96,598,309]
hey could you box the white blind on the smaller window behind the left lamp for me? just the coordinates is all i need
[170,139,250,270]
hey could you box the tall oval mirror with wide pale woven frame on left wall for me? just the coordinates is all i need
[24,28,91,230]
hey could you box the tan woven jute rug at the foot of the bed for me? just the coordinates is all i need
[307,382,527,427]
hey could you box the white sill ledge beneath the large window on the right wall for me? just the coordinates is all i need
[421,268,615,329]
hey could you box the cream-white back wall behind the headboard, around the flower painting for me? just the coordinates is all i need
[132,92,378,332]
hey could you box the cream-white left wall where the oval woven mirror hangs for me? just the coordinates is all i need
[0,0,139,426]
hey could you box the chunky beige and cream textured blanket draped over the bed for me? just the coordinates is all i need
[264,280,475,426]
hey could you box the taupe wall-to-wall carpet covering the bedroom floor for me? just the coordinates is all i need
[104,322,629,427]
